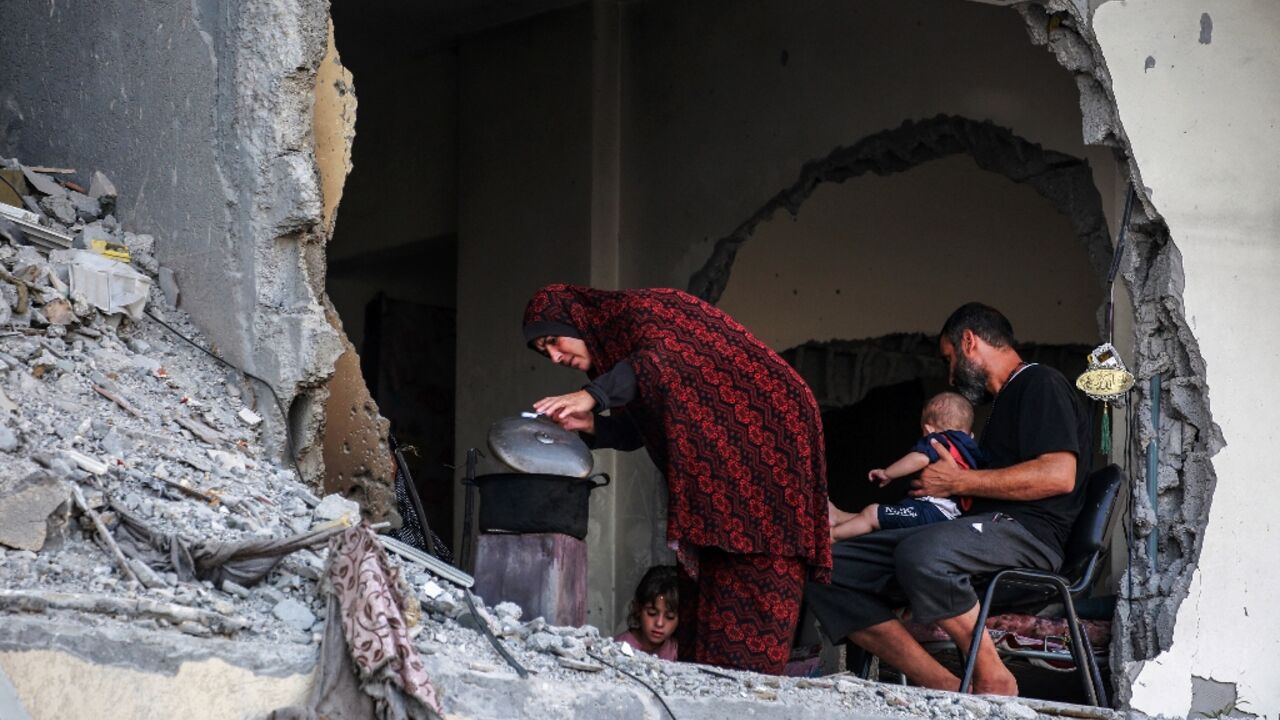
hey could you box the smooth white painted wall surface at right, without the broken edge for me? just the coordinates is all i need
[1093,0,1280,717]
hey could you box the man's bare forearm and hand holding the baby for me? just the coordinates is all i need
[911,441,1075,501]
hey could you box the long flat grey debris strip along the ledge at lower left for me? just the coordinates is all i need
[0,589,248,635]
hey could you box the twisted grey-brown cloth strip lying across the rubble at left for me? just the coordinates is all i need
[111,501,343,588]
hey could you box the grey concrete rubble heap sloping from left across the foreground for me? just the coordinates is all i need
[0,161,1117,720]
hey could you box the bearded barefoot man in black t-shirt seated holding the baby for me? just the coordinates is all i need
[806,302,1092,694]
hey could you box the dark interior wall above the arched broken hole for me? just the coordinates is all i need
[622,1,1115,294]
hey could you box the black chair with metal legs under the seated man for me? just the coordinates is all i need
[960,465,1125,706]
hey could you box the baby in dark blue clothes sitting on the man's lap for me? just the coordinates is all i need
[829,392,986,541]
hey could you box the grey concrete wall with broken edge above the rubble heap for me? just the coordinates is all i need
[0,0,340,478]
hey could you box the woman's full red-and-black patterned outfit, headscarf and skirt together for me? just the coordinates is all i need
[525,284,831,673]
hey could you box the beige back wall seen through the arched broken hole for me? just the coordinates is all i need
[708,126,1111,347]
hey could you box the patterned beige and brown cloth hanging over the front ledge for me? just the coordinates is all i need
[270,525,444,720]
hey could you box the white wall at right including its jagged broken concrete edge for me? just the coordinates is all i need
[1092,0,1280,717]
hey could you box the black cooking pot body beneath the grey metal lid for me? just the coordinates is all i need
[463,473,609,539]
